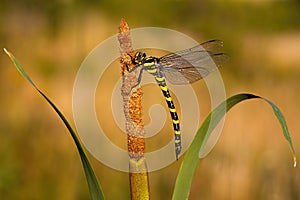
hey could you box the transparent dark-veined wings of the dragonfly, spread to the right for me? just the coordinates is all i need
[159,40,229,85]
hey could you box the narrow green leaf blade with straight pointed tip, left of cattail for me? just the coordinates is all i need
[4,49,104,200]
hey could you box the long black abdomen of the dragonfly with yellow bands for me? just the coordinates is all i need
[147,65,181,160]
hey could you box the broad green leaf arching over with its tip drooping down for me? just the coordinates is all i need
[172,94,296,200]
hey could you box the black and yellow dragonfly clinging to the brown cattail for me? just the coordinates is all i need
[128,40,229,160]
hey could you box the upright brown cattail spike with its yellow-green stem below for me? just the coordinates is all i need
[118,19,150,200]
